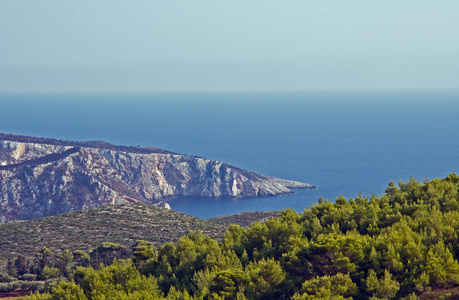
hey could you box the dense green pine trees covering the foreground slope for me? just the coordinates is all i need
[0,174,459,300]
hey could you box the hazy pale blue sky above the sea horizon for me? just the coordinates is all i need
[0,0,459,91]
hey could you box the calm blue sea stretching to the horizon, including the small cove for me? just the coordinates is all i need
[0,89,459,219]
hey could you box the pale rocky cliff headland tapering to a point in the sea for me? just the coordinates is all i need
[0,137,315,223]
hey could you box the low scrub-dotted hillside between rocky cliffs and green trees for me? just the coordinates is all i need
[0,203,226,260]
